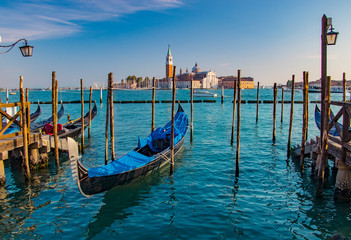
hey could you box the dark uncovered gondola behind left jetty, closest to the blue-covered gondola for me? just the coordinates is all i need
[57,101,97,138]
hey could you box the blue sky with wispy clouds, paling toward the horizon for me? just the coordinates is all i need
[0,0,351,88]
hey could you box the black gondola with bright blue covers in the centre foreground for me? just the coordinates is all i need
[71,104,188,196]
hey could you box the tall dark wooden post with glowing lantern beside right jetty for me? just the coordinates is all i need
[318,15,339,184]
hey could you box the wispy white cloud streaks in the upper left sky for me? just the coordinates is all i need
[0,0,182,42]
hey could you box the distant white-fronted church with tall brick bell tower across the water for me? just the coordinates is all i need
[158,45,218,89]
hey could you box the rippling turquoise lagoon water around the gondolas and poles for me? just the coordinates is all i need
[0,89,351,239]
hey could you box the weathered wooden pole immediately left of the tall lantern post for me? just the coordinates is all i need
[300,72,308,171]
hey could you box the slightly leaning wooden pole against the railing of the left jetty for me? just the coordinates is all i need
[20,76,31,178]
